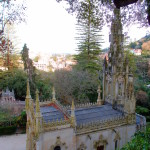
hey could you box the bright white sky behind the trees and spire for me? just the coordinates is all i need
[17,0,150,54]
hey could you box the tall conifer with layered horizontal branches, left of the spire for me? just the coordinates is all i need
[75,0,101,71]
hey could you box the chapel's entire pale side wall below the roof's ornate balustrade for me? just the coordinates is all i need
[37,125,136,150]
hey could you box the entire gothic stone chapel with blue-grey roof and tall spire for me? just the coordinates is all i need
[26,9,146,150]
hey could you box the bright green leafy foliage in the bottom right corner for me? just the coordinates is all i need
[121,129,150,150]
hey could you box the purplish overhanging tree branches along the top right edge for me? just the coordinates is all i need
[56,0,150,27]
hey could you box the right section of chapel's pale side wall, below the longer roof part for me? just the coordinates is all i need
[77,125,136,150]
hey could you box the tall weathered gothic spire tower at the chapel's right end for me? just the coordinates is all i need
[103,9,135,112]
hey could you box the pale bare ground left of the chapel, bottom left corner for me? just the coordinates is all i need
[0,134,26,150]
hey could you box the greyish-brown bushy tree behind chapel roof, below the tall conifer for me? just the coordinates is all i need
[54,69,98,103]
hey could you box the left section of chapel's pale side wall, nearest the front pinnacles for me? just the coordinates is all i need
[37,128,76,150]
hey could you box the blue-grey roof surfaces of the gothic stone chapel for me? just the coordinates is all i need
[40,104,146,125]
